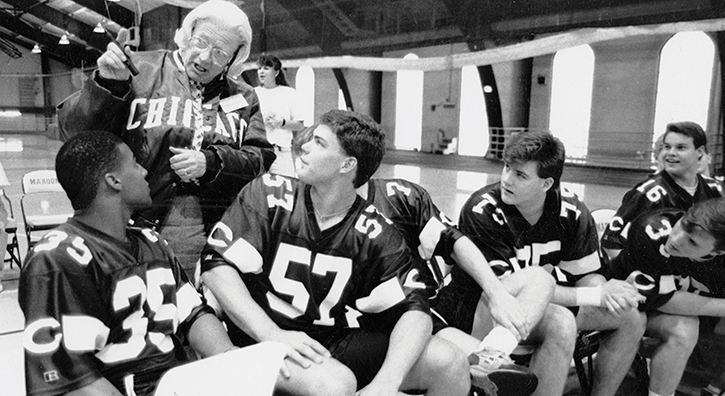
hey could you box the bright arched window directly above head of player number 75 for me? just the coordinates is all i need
[549,45,594,158]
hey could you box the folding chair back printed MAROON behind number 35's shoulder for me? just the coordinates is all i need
[20,170,73,251]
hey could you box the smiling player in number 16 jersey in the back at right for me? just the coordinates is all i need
[602,121,722,259]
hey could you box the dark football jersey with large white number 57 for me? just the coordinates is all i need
[201,174,434,342]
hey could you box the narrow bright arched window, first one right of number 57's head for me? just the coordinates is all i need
[395,54,423,150]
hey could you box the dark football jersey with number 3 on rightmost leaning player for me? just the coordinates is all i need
[611,209,725,311]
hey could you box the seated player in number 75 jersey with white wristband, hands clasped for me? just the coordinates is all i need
[444,132,645,395]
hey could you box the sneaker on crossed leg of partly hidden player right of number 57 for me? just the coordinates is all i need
[468,348,539,396]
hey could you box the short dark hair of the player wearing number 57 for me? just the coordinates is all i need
[320,110,385,188]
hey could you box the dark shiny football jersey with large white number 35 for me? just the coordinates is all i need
[18,218,212,396]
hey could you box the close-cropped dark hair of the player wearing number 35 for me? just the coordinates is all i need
[55,131,123,210]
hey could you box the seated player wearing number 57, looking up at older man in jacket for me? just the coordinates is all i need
[201,110,470,395]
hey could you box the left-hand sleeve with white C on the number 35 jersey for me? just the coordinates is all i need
[18,231,110,395]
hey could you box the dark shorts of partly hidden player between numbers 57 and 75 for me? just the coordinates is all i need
[430,286,481,334]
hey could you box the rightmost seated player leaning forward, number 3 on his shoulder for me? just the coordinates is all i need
[611,198,725,396]
